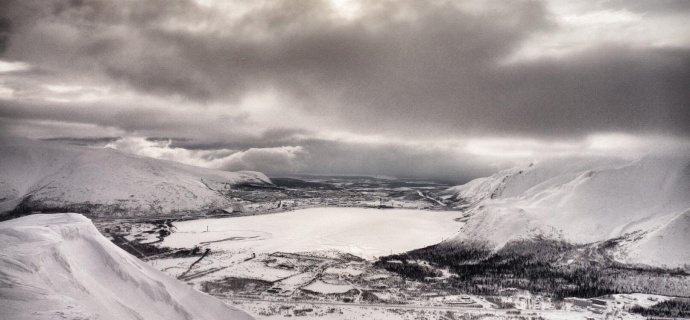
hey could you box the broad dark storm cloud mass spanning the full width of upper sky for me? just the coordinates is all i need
[4,0,690,135]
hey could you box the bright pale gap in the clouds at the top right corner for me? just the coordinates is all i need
[503,0,690,64]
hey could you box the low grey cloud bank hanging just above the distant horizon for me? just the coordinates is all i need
[175,138,495,183]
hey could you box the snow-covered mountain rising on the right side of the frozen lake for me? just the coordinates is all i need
[448,152,690,267]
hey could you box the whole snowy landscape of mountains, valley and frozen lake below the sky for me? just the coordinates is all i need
[0,141,690,319]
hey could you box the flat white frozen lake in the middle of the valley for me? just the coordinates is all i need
[163,208,462,259]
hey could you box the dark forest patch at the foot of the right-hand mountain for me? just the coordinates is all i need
[376,239,690,299]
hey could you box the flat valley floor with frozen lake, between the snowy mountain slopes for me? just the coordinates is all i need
[87,174,690,319]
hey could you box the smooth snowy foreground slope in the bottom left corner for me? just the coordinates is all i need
[0,213,252,320]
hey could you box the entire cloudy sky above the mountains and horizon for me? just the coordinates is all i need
[0,0,690,182]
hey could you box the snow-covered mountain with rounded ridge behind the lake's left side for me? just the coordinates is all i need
[0,139,272,219]
